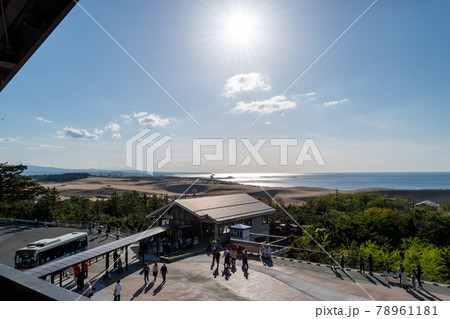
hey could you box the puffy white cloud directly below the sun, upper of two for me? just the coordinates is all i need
[222,72,271,97]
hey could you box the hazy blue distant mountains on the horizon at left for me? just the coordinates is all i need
[24,165,174,176]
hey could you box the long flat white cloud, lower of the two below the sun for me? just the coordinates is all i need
[231,95,296,114]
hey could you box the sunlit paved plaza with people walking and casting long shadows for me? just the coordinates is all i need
[73,247,450,301]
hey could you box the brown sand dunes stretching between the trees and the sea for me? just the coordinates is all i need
[41,176,450,204]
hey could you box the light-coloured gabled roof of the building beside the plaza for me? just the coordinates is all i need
[147,194,275,223]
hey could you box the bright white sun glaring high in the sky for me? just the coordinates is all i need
[224,12,257,44]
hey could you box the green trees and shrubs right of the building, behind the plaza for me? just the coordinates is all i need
[266,192,450,282]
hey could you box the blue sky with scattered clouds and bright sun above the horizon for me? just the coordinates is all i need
[0,0,450,173]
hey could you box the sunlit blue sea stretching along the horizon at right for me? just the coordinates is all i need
[176,172,450,190]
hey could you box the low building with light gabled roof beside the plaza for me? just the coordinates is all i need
[147,194,275,246]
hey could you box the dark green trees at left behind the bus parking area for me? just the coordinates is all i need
[0,163,171,230]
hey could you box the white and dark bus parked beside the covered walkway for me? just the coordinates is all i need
[14,232,88,270]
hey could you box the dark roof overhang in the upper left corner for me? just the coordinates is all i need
[0,0,78,92]
